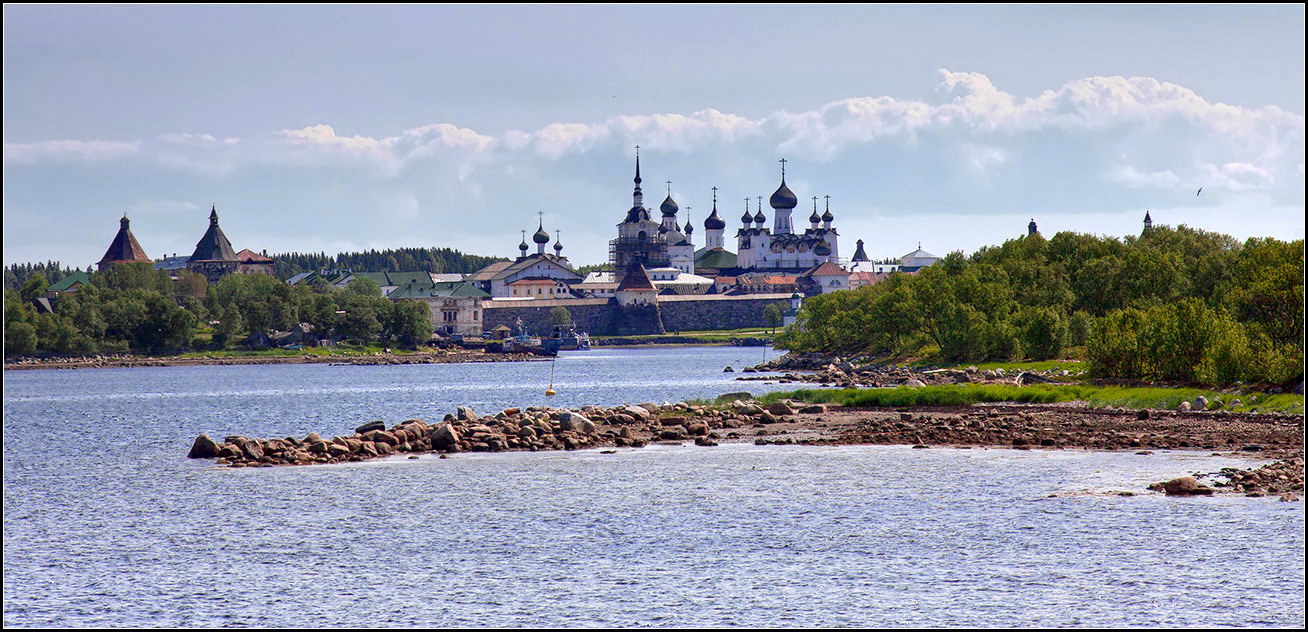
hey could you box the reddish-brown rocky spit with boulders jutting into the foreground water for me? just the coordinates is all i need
[187,400,1304,500]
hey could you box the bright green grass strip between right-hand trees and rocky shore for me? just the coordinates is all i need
[763,385,1304,413]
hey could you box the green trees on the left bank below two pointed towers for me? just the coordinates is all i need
[4,263,432,356]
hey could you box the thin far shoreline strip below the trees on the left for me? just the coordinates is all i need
[4,349,542,370]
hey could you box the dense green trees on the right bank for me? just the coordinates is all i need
[777,226,1304,386]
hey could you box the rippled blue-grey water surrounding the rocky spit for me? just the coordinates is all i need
[4,348,1304,627]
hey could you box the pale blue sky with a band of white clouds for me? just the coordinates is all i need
[3,4,1304,268]
